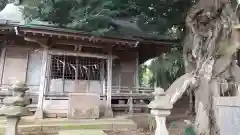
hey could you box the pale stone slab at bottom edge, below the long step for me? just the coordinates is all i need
[58,129,107,135]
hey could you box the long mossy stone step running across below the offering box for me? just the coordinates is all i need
[0,118,137,135]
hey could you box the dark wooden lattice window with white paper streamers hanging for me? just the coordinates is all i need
[51,55,104,80]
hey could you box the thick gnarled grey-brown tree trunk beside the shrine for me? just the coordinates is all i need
[184,0,238,135]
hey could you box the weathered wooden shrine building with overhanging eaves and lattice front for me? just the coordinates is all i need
[0,2,178,117]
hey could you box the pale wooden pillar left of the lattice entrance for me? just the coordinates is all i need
[35,47,48,119]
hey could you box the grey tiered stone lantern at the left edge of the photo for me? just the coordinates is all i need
[0,82,31,135]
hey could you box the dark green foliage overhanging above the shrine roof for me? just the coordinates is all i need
[22,0,194,38]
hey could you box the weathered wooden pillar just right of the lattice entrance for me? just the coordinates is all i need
[105,53,113,117]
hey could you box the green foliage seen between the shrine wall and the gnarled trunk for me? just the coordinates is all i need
[139,48,185,89]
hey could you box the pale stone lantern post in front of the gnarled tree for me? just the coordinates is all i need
[148,88,173,135]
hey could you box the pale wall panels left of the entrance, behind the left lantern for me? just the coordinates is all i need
[0,45,42,92]
